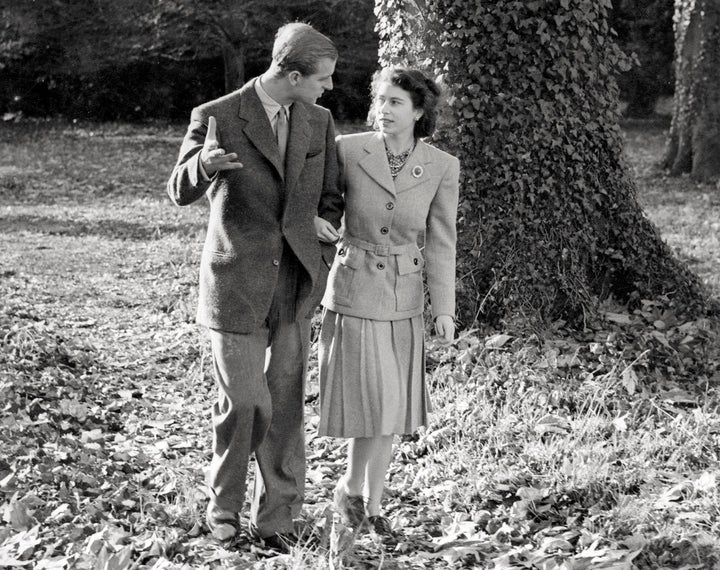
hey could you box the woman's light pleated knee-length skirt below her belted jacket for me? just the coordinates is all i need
[318,309,430,437]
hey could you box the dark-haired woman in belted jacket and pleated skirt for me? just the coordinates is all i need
[318,68,459,540]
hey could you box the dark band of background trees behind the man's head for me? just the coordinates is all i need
[0,0,377,120]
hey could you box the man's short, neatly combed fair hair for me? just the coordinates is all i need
[273,22,338,75]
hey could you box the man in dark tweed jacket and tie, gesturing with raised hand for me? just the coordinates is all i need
[167,23,343,549]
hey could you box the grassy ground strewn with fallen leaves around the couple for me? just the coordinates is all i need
[0,116,720,570]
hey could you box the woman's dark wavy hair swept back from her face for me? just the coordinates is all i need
[368,67,440,138]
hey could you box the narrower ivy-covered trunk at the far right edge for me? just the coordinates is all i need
[664,0,720,182]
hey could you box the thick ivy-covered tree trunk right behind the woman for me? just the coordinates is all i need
[376,0,705,326]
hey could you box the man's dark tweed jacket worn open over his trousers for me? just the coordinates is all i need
[167,79,343,333]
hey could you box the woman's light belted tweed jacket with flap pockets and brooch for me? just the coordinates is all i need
[322,132,460,320]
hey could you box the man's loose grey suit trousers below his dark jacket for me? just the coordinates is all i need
[208,244,310,537]
